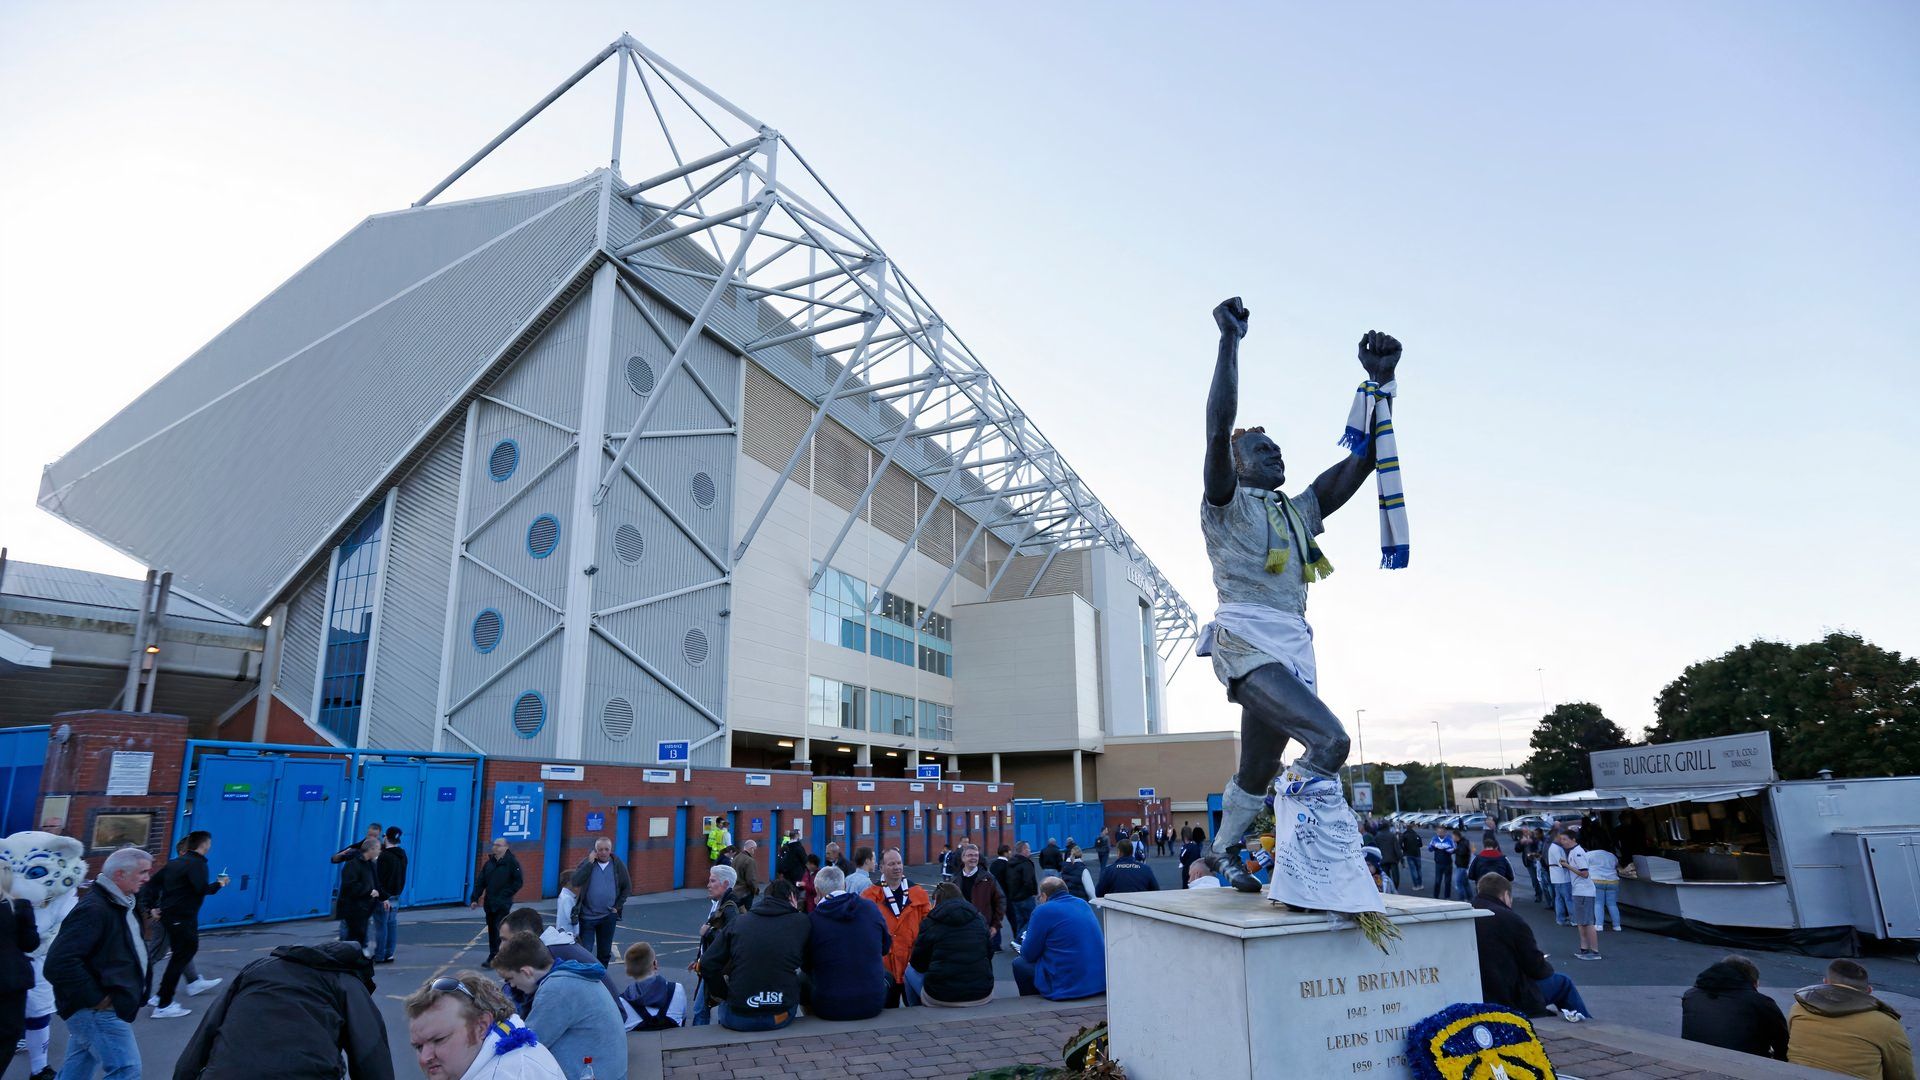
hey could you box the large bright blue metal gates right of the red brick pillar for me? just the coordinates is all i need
[173,740,480,926]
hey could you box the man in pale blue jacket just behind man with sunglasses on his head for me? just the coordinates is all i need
[493,934,626,1080]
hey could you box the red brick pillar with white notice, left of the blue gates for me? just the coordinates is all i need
[36,711,186,871]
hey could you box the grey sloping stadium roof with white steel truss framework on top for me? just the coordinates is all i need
[38,35,1196,657]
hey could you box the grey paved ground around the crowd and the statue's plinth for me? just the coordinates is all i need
[54,859,1920,1080]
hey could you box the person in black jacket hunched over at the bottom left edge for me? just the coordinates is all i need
[173,942,394,1080]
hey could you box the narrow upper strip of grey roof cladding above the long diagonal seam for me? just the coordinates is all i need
[48,181,591,486]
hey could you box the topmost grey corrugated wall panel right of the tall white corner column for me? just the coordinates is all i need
[607,294,739,434]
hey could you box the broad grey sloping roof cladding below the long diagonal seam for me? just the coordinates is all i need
[44,192,595,613]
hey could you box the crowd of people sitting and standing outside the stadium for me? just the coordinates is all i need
[11,810,1914,1080]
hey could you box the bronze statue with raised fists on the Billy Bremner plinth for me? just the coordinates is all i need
[1200,296,1404,892]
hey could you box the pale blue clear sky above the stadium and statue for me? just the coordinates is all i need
[0,0,1920,765]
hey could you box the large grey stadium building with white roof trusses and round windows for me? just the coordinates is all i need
[29,37,1194,801]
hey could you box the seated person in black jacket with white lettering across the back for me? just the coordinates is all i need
[701,880,812,1032]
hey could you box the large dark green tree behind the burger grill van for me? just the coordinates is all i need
[1651,634,1920,780]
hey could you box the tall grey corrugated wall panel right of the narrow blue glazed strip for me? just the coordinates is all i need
[367,430,463,746]
